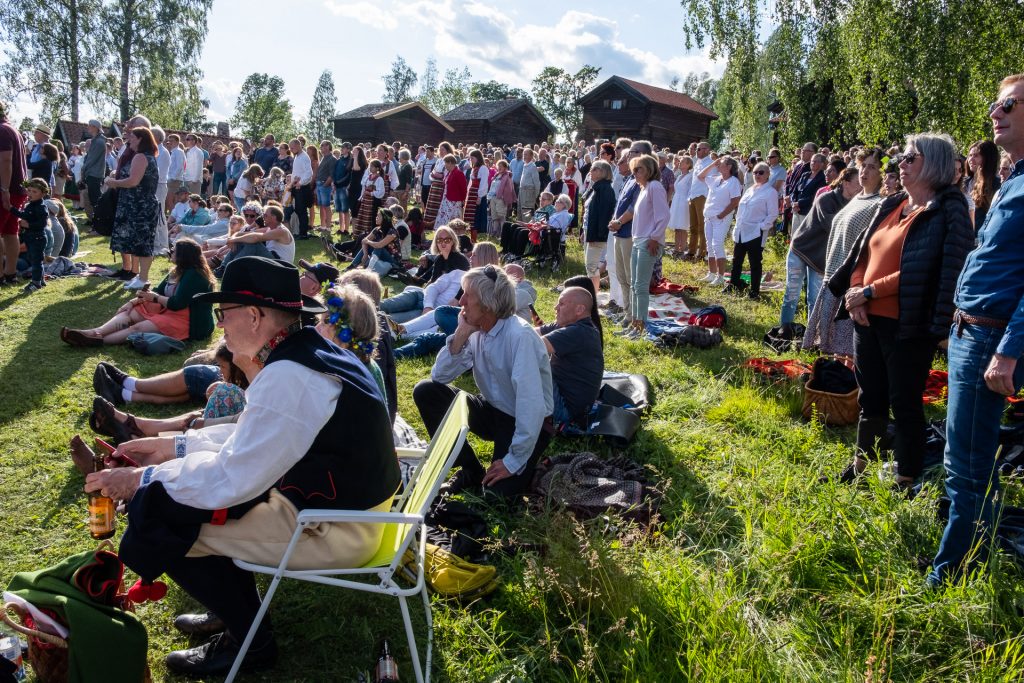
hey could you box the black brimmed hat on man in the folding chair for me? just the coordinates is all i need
[195,256,327,313]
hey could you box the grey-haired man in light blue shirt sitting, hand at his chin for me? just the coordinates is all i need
[413,265,552,497]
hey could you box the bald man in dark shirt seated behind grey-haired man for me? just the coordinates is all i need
[537,287,604,424]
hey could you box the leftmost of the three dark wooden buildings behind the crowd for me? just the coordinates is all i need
[333,102,455,150]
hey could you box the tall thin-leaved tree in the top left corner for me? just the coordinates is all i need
[0,0,101,121]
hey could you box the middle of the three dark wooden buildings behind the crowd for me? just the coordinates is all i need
[443,99,555,145]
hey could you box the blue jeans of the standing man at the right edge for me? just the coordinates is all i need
[928,325,1024,586]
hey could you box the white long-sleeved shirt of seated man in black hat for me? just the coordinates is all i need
[152,360,341,510]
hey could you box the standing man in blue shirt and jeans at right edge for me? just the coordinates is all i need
[928,74,1024,586]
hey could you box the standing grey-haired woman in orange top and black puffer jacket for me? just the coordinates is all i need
[827,133,974,493]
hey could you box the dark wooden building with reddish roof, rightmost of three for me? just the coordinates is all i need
[579,76,718,150]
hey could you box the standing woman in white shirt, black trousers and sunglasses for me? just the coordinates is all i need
[724,162,778,299]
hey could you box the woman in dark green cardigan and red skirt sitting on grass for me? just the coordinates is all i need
[60,238,216,346]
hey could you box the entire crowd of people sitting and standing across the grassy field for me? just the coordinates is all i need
[0,69,1024,676]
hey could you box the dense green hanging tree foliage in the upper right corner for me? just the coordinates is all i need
[682,0,1024,146]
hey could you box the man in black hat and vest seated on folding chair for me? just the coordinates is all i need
[85,257,400,677]
